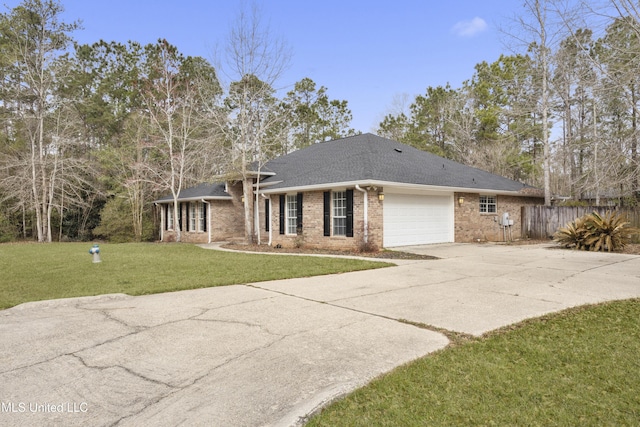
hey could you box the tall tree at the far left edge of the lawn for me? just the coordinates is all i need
[0,0,78,242]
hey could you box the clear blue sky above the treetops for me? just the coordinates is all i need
[5,0,522,132]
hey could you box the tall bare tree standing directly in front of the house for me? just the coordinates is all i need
[217,5,291,243]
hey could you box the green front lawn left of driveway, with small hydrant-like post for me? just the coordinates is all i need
[0,243,390,309]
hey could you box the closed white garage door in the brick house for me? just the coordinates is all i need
[383,193,454,247]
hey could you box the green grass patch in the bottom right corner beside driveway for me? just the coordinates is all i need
[308,299,640,426]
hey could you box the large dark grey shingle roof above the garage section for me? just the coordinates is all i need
[263,133,533,192]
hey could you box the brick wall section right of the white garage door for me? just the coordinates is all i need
[454,193,543,243]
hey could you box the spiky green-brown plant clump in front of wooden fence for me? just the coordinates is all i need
[553,211,639,252]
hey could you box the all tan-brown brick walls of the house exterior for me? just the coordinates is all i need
[163,182,542,246]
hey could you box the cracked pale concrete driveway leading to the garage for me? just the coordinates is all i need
[0,244,640,426]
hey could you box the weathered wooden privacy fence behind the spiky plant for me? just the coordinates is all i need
[521,206,640,239]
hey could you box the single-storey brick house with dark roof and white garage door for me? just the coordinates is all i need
[156,134,543,249]
